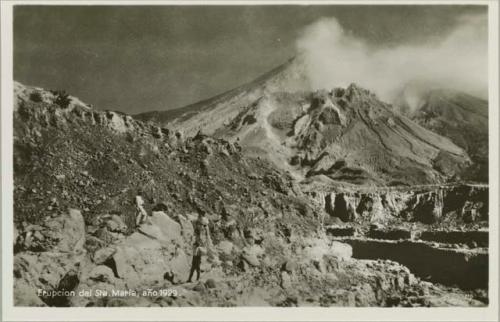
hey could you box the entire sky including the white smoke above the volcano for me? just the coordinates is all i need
[14,5,488,114]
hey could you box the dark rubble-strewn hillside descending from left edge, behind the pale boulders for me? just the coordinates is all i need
[14,83,310,227]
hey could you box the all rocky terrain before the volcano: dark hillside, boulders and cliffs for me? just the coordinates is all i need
[14,84,488,306]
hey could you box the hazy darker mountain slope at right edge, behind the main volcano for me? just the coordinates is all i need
[394,84,488,182]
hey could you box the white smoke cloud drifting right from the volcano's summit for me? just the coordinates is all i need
[296,15,488,102]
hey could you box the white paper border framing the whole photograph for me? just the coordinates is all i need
[1,0,500,321]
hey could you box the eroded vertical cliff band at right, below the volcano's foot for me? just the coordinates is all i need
[318,185,488,224]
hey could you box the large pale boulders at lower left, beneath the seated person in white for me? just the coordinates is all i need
[14,209,196,306]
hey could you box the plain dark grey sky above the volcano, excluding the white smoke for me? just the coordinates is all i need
[14,5,487,114]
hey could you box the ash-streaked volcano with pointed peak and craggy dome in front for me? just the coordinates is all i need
[139,59,469,185]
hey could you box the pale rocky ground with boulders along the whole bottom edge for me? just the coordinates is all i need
[14,210,487,306]
